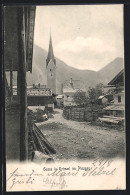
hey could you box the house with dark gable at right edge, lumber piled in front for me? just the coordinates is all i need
[99,69,125,123]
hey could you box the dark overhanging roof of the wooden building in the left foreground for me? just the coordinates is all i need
[4,6,36,71]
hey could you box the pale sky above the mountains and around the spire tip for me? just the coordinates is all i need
[34,5,124,71]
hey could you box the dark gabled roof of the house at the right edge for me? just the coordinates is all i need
[108,69,124,86]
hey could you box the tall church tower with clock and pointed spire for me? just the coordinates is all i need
[46,34,56,94]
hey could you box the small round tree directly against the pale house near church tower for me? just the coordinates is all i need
[73,90,87,106]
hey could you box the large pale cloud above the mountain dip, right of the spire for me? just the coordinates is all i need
[55,36,123,70]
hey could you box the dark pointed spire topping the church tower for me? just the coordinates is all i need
[46,33,56,67]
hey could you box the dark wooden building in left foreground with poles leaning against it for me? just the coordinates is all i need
[4,6,55,161]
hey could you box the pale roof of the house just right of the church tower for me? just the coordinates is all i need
[63,79,86,92]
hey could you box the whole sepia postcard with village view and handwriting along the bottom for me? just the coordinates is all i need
[3,4,126,191]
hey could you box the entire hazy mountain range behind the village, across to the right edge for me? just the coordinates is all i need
[7,45,123,94]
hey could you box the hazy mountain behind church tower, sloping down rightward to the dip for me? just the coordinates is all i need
[27,45,97,93]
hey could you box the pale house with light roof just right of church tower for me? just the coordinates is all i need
[63,78,86,107]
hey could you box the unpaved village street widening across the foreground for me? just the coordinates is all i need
[37,109,125,160]
